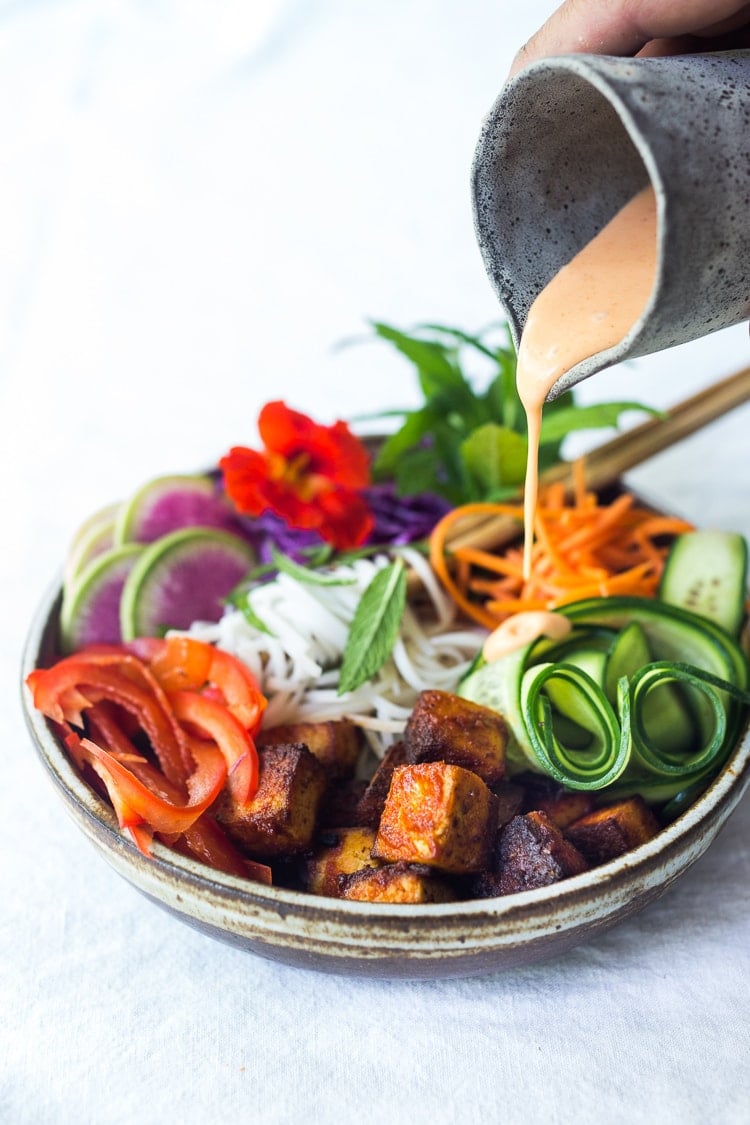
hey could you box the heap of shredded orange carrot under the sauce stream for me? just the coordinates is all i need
[430,459,693,629]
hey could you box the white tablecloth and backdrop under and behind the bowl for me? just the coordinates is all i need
[0,0,750,1125]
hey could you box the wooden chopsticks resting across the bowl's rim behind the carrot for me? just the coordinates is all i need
[448,367,750,549]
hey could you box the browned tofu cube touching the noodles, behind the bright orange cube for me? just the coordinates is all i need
[404,691,508,785]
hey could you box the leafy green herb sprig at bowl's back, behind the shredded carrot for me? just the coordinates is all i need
[355,321,658,504]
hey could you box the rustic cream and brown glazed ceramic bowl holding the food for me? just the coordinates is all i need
[22,586,750,978]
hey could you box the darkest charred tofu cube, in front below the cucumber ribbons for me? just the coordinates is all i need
[478,812,588,897]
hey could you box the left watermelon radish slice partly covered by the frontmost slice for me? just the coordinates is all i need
[60,543,145,653]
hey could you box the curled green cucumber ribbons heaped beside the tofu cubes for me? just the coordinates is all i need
[462,597,750,802]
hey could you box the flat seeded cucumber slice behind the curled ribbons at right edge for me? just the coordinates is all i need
[659,531,748,637]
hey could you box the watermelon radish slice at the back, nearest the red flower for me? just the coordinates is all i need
[115,475,237,543]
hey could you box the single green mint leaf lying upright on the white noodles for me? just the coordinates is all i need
[338,558,406,695]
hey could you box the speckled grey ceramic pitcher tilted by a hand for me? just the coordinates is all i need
[472,51,750,397]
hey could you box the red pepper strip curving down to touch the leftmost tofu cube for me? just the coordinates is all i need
[169,692,259,804]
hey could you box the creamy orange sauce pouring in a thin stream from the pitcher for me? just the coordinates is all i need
[516,187,657,577]
